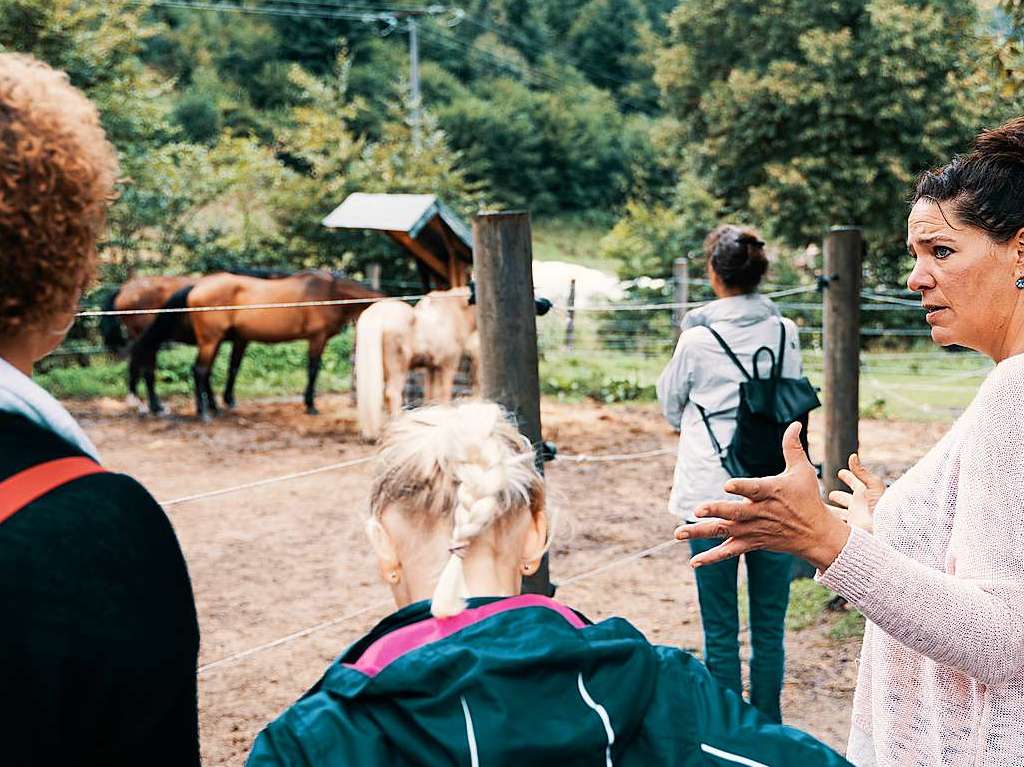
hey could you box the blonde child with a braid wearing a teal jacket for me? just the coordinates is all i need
[248,402,848,767]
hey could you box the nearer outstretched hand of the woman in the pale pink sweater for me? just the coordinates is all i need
[676,423,850,570]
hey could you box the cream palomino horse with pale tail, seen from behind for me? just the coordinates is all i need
[355,288,479,439]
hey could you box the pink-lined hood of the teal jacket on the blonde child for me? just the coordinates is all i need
[272,595,657,765]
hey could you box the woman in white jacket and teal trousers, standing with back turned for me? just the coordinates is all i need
[657,224,803,722]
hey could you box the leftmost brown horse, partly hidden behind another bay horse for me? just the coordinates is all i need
[99,274,196,414]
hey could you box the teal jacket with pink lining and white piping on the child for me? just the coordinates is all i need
[248,595,849,767]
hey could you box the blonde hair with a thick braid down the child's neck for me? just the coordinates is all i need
[370,401,544,617]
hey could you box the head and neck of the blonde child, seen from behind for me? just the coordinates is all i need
[367,402,549,617]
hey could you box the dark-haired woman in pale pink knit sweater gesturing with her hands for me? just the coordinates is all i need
[677,118,1024,767]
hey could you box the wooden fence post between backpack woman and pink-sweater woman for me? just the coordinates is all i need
[822,226,864,491]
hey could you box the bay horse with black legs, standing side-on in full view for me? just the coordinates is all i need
[184,271,383,420]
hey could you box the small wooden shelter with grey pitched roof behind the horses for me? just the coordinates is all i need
[323,191,473,288]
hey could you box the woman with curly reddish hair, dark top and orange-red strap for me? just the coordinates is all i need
[0,53,199,767]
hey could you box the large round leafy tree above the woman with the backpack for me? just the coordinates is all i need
[657,0,995,280]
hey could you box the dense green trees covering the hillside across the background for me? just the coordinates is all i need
[0,0,1024,283]
